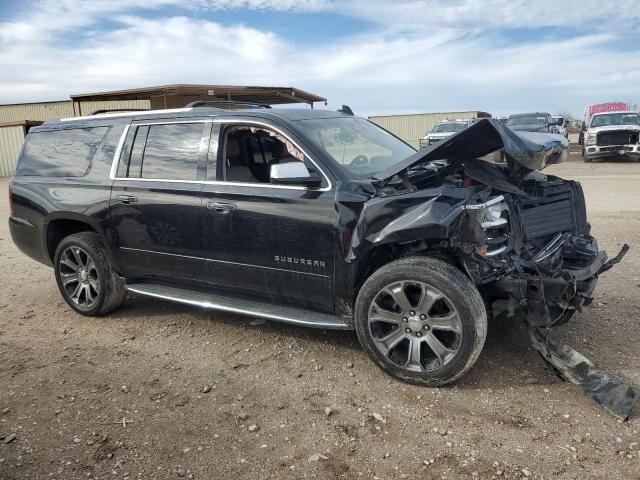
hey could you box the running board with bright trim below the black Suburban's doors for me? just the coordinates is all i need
[127,283,351,330]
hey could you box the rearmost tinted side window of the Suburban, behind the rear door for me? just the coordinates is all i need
[16,127,109,177]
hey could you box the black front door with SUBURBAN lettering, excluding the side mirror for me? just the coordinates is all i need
[202,120,337,312]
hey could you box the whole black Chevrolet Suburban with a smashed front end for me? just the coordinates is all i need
[10,102,636,416]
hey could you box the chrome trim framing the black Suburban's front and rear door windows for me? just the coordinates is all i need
[109,119,333,192]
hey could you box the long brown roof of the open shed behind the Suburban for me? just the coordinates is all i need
[71,84,327,105]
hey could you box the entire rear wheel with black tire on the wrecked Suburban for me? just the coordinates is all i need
[54,232,127,317]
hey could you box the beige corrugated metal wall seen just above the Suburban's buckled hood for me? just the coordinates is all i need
[369,111,478,149]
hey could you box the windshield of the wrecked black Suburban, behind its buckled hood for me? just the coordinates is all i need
[297,117,416,177]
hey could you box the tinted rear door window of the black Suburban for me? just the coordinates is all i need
[138,123,203,180]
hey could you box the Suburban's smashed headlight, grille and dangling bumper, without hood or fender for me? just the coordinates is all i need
[452,168,638,420]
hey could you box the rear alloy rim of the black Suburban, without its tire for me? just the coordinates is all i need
[58,246,100,309]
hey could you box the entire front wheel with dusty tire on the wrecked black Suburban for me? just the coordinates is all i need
[354,257,487,386]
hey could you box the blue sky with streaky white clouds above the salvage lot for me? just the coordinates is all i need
[0,0,640,116]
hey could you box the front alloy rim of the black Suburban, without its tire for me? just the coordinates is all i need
[368,280,463,372]
